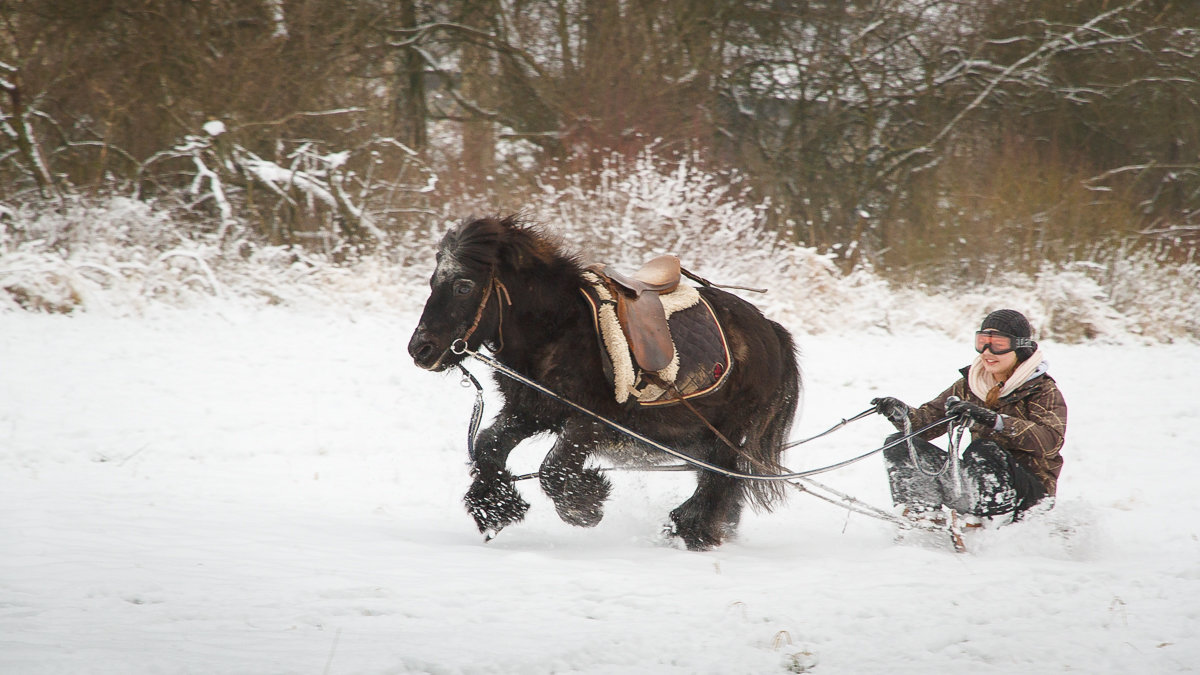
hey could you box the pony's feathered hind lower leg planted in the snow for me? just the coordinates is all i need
[667,471,743,551]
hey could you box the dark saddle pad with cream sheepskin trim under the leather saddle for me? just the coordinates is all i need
[581,270,732,406]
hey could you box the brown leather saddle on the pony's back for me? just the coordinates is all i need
[589,256,680,372]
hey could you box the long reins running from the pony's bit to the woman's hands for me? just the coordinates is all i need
[450,339,955,480]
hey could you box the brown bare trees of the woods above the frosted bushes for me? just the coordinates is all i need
[0,0,1200,265]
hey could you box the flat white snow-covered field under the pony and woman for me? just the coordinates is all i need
[0,304,1200,674]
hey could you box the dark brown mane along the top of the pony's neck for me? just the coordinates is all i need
[439,215,582,274]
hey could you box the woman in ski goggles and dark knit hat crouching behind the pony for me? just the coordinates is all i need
[871,310,1067,520]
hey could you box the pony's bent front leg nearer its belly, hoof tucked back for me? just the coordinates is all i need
[539,423,612,527]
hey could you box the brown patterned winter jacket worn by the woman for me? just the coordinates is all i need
[911,368,1067,495]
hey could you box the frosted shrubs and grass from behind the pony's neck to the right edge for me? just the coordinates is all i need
[499,151,1200,342]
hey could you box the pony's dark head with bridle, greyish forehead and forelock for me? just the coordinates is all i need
[408,216,557,371]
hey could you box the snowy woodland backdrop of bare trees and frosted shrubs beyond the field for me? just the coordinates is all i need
[0,0,1200,341]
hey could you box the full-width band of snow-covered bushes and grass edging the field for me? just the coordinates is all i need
[0,151,1200,342]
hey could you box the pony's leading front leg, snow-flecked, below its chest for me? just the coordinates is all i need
[463,416,538,540]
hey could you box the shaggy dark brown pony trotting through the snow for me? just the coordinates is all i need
[408,217,800,550]
